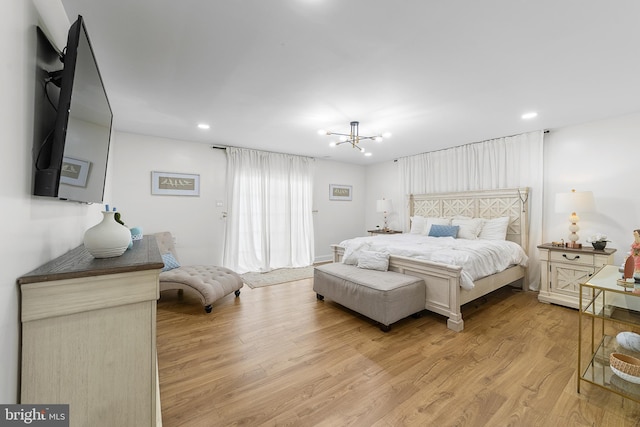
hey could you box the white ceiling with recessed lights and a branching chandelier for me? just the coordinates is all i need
[62,0,640,164]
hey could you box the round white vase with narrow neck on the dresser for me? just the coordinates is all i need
[84,212,131,258]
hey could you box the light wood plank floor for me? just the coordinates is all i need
[157,279,640,427]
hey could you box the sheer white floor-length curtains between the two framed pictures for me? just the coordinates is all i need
[223,147,314,273]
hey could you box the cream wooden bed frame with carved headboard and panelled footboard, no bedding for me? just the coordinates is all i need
[332,188,529,331]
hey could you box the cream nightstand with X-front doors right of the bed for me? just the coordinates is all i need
[538,243,616,308]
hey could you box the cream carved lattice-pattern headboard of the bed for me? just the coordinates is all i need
[409,187,529,252]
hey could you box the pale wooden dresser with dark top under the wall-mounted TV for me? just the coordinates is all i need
[18,236,163,427]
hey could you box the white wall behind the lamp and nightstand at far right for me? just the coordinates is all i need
[542,113,640,264]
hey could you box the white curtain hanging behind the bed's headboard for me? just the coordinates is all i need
[398,131,544,290]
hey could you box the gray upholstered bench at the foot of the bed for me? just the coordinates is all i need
[313,262,426,332]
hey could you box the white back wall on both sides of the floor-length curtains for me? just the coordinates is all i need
[109,132,366,265]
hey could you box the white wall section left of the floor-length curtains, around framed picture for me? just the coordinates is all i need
[109,132,226,265]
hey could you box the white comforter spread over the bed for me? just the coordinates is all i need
[340,233,528,289]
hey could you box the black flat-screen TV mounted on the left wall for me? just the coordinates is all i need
[33,16,113,203]
